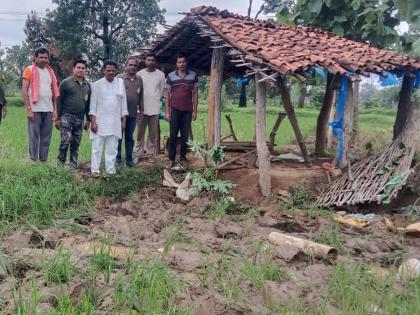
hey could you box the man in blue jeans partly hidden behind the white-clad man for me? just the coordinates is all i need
[116,58,143,167]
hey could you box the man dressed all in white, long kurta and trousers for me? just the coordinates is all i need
[89,61,128,176]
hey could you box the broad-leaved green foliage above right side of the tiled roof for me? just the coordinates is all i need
[275,0,400,48]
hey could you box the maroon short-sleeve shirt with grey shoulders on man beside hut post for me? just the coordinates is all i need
[165,70,198,111]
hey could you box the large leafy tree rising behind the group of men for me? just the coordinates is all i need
[46,0,164,74]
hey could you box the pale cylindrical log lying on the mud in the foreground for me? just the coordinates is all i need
[268,232,338,259]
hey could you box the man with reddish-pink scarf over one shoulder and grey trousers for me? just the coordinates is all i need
[22,47,60,162]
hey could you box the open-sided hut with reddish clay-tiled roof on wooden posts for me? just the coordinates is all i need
[139,6,420,200]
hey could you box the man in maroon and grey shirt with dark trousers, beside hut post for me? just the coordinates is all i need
[165,55,198,168]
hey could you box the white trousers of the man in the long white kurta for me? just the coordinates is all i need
[90,136,118,174]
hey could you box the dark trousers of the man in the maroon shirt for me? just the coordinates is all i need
[169,108,192,161]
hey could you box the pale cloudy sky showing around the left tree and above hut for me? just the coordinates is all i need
[0,0,263,47]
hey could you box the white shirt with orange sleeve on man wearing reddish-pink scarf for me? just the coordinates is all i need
[22,65,54,112]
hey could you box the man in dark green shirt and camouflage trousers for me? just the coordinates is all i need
[55,60,91,169]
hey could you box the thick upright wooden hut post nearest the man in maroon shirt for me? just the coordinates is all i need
[207,48,224,148]
